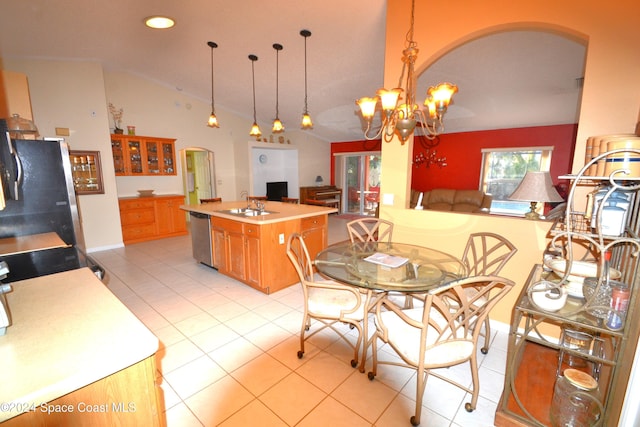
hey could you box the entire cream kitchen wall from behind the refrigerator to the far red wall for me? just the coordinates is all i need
[2,58,330,251]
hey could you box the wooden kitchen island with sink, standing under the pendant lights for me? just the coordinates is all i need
[180,201,338,294]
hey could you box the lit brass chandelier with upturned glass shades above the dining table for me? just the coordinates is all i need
[356,0,458,144]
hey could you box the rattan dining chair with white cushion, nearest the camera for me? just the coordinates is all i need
[368,276,515,426]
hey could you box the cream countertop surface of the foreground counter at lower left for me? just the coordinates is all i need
[0,268,158,422]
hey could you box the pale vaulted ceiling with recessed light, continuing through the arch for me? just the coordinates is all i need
[0,0,586,141]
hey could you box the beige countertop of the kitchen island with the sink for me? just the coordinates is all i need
[180,200,338,224]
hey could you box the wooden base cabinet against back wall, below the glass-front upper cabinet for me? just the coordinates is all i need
[118,195,187,244]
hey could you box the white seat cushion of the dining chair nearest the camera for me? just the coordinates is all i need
[380,308,474,367]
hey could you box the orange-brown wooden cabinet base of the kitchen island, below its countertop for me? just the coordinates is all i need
[211,214,328,294]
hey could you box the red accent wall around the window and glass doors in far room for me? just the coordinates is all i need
[331,124,578,191]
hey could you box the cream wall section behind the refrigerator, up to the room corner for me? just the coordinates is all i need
[3,58,122,250]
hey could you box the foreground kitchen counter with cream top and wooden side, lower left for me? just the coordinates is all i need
[0,268,166,426]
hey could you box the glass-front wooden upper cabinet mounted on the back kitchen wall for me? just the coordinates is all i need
[111,135,176,176]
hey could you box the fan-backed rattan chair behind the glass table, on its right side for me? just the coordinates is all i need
[462,232,518,354]
